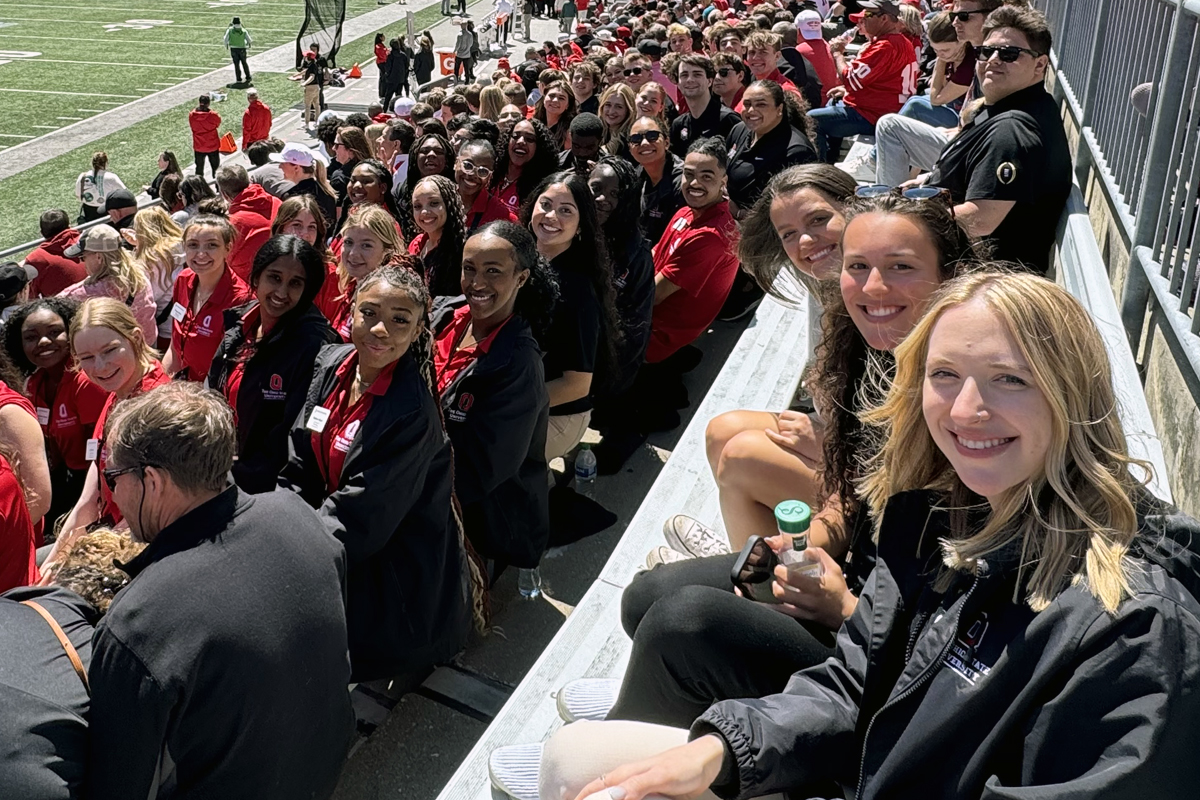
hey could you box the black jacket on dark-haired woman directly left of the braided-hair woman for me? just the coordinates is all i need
[208,300,338,494]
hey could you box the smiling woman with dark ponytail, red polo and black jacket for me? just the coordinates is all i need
[433,222,558,579]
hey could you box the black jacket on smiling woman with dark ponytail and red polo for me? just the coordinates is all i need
[433,296,550,569]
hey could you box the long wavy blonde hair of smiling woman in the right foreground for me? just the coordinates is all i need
[859,272,1152,613]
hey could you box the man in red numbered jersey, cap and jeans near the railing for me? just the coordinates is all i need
[809,0,920,164]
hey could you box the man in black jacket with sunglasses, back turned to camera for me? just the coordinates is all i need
[88,383,354,800]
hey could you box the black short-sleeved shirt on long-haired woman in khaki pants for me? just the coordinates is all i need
[541,256,601,416]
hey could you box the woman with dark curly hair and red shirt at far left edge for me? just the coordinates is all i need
[4,297,110,523]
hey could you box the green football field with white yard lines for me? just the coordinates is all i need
[0,0,388,149]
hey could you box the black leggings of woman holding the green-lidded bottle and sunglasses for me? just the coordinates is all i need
[608,554,836,728]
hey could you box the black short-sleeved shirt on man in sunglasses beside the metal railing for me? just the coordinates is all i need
[929,84,1070,273]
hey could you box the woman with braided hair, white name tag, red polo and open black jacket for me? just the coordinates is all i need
[280,265,482,682]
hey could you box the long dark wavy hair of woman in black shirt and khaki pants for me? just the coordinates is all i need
[521,169,624,391]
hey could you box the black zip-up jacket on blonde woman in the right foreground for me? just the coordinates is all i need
[692,492,1200,800]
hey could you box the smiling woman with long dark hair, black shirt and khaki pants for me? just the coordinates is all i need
[521,170,622,461]
